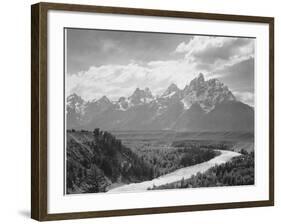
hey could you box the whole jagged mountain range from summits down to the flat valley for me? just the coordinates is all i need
[66,73,254,131]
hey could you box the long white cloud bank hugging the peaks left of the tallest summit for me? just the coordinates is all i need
[67,60,203,100]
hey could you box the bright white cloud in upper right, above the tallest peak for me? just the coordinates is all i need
[175,36,254,72]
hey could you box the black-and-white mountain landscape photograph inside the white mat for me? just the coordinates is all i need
[64,28,256,194]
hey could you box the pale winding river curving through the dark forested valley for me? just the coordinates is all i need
[108,150,240,193]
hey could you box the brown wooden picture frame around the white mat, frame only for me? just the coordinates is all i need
[31,3,274,221]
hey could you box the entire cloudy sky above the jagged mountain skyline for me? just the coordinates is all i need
[66,29,255,106]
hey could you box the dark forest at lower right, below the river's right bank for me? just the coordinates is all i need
[148,149,254,190]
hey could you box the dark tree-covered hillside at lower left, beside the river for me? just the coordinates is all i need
[66,129,152,194]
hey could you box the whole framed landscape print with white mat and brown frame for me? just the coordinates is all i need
[31,3,274,221]
